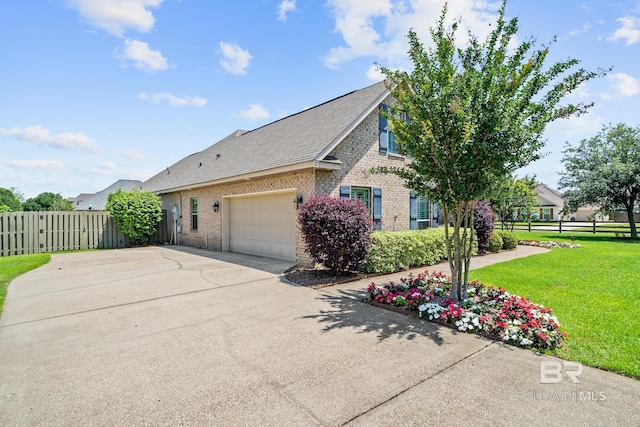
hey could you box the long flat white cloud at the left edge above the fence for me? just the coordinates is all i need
[0,125,102,153]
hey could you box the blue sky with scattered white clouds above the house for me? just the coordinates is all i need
[0,0,640,198]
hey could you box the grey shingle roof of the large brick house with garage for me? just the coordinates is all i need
[142,82,388,192]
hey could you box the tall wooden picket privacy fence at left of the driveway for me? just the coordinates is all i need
[0,211,167,256]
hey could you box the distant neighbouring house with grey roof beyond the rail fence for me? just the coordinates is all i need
[532,185,609,221]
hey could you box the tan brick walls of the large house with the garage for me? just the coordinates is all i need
[162,95,410,266]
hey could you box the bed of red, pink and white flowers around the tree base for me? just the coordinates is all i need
[367,271,566,350]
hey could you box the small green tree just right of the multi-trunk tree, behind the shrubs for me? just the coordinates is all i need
[489,174,538,231]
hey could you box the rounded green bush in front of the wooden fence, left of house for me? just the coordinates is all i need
[107,190,162,245]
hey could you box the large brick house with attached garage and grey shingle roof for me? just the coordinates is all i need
[142,82,432,264]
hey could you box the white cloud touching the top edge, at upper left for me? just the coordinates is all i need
[69,0,163,37]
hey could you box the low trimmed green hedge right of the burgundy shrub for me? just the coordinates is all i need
[362,227,478,273]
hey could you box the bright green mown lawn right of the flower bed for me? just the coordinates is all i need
[470,232,640,379]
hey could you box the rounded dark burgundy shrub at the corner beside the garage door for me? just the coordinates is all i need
[298,196,372,272]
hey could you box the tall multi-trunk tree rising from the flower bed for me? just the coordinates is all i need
[374,1,606,301]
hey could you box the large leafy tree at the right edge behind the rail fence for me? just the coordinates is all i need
[559,123,640,239]
